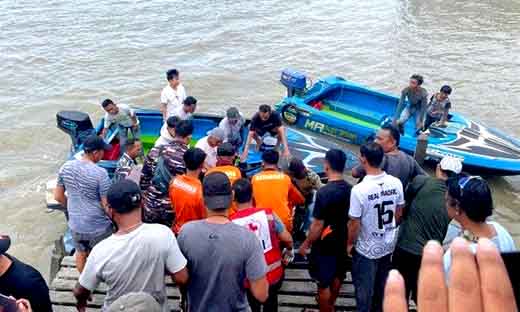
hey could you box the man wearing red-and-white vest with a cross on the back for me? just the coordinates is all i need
[230,179,294,312]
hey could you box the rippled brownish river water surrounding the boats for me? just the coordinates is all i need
[0,0,520,276]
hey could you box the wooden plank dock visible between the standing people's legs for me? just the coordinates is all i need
[50,257,356,312]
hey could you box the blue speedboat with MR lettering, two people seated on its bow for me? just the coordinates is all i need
[276,70,520,175]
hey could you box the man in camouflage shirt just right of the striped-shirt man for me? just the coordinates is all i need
[114,139,142,184]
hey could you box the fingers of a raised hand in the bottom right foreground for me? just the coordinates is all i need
[384,238,517,312]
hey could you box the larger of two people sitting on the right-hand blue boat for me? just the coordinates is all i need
[394,74,428,134]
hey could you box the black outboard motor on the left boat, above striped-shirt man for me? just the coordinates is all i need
[56,111,96,153]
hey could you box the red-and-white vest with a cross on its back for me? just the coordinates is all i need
[230,208,283,285]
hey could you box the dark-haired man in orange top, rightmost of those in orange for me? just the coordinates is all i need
[251,150,305,232]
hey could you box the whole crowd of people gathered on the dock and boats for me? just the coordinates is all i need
[0,70,516,312]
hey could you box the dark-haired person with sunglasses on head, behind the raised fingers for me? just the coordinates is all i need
[443,176,516,277]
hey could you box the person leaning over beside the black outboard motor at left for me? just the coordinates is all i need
[101,99,141,155]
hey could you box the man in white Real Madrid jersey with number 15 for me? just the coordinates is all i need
[347,143,404,312]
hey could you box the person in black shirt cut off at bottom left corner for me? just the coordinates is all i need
[0,235,52,312]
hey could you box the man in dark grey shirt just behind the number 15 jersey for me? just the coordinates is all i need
[352,125,426,189]
